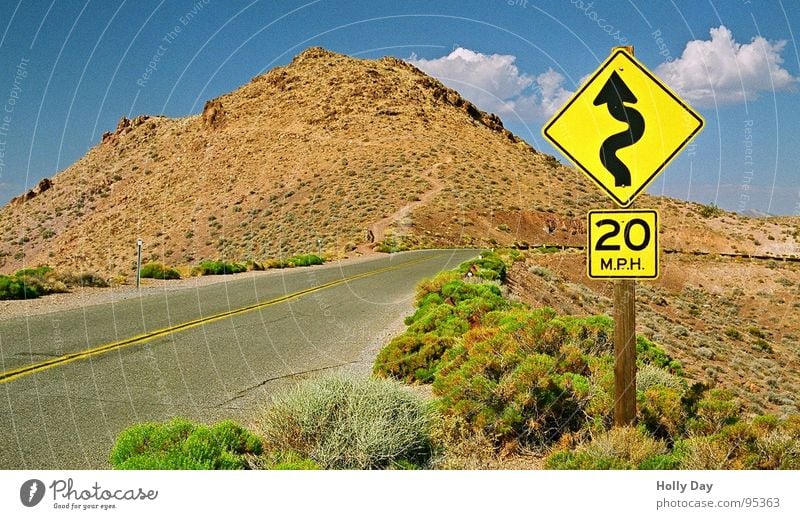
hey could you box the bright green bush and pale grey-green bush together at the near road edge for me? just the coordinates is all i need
[109,375,436,470]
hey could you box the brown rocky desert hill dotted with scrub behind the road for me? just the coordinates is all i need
[0,48,800,276]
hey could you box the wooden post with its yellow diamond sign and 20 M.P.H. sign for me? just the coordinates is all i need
[542,46,704,426]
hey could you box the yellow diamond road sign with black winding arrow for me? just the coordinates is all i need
[542,49,703,207]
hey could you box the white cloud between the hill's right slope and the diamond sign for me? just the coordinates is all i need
[407,47,572,121]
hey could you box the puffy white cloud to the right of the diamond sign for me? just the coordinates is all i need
[656,25,797,106]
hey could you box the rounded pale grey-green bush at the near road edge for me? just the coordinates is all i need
[259,376,434,469]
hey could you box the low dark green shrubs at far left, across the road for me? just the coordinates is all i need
[0,266,108,300]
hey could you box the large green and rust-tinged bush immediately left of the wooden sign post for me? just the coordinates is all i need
[424,308,613,449]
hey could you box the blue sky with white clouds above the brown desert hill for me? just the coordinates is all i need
[0,0,800,214]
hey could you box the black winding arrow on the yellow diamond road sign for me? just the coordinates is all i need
[594,71,644,187]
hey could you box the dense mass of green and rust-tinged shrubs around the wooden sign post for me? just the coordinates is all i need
[374,250,800,469]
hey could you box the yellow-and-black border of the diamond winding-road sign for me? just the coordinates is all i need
[542,48,706,208]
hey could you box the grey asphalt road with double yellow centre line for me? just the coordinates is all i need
[0,250,477,469]
